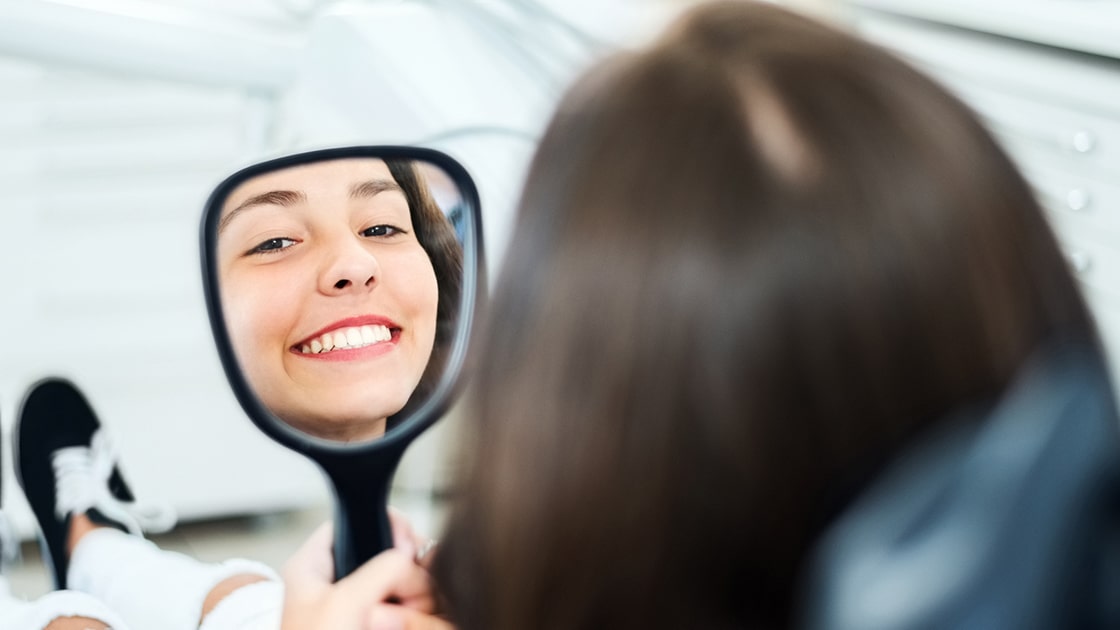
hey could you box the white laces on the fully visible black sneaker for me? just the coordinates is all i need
[50,428,175,536]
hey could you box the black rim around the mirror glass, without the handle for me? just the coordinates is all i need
[200,145,486,459]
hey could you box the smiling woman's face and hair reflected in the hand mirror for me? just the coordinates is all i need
[218,159,461,441]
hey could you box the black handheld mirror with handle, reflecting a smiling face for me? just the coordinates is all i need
[202,147,484,577]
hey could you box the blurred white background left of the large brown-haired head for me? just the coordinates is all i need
[0,0,688,536]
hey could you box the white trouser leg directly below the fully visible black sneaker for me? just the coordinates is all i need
[66,528,283,630]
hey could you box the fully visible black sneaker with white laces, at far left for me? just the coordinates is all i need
[12,378,175,589]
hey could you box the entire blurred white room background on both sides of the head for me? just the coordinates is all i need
[0,0,1120,537]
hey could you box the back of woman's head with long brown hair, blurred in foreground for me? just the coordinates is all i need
[436,2,1093,630]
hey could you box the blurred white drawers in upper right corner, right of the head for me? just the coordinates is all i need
[840,0,1120,386]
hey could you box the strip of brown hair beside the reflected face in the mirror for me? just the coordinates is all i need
[385,159,463,430]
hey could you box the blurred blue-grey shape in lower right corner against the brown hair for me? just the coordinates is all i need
[802,344,1120,630]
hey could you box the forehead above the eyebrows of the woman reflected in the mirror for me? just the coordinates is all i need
[222,158,393,216]
